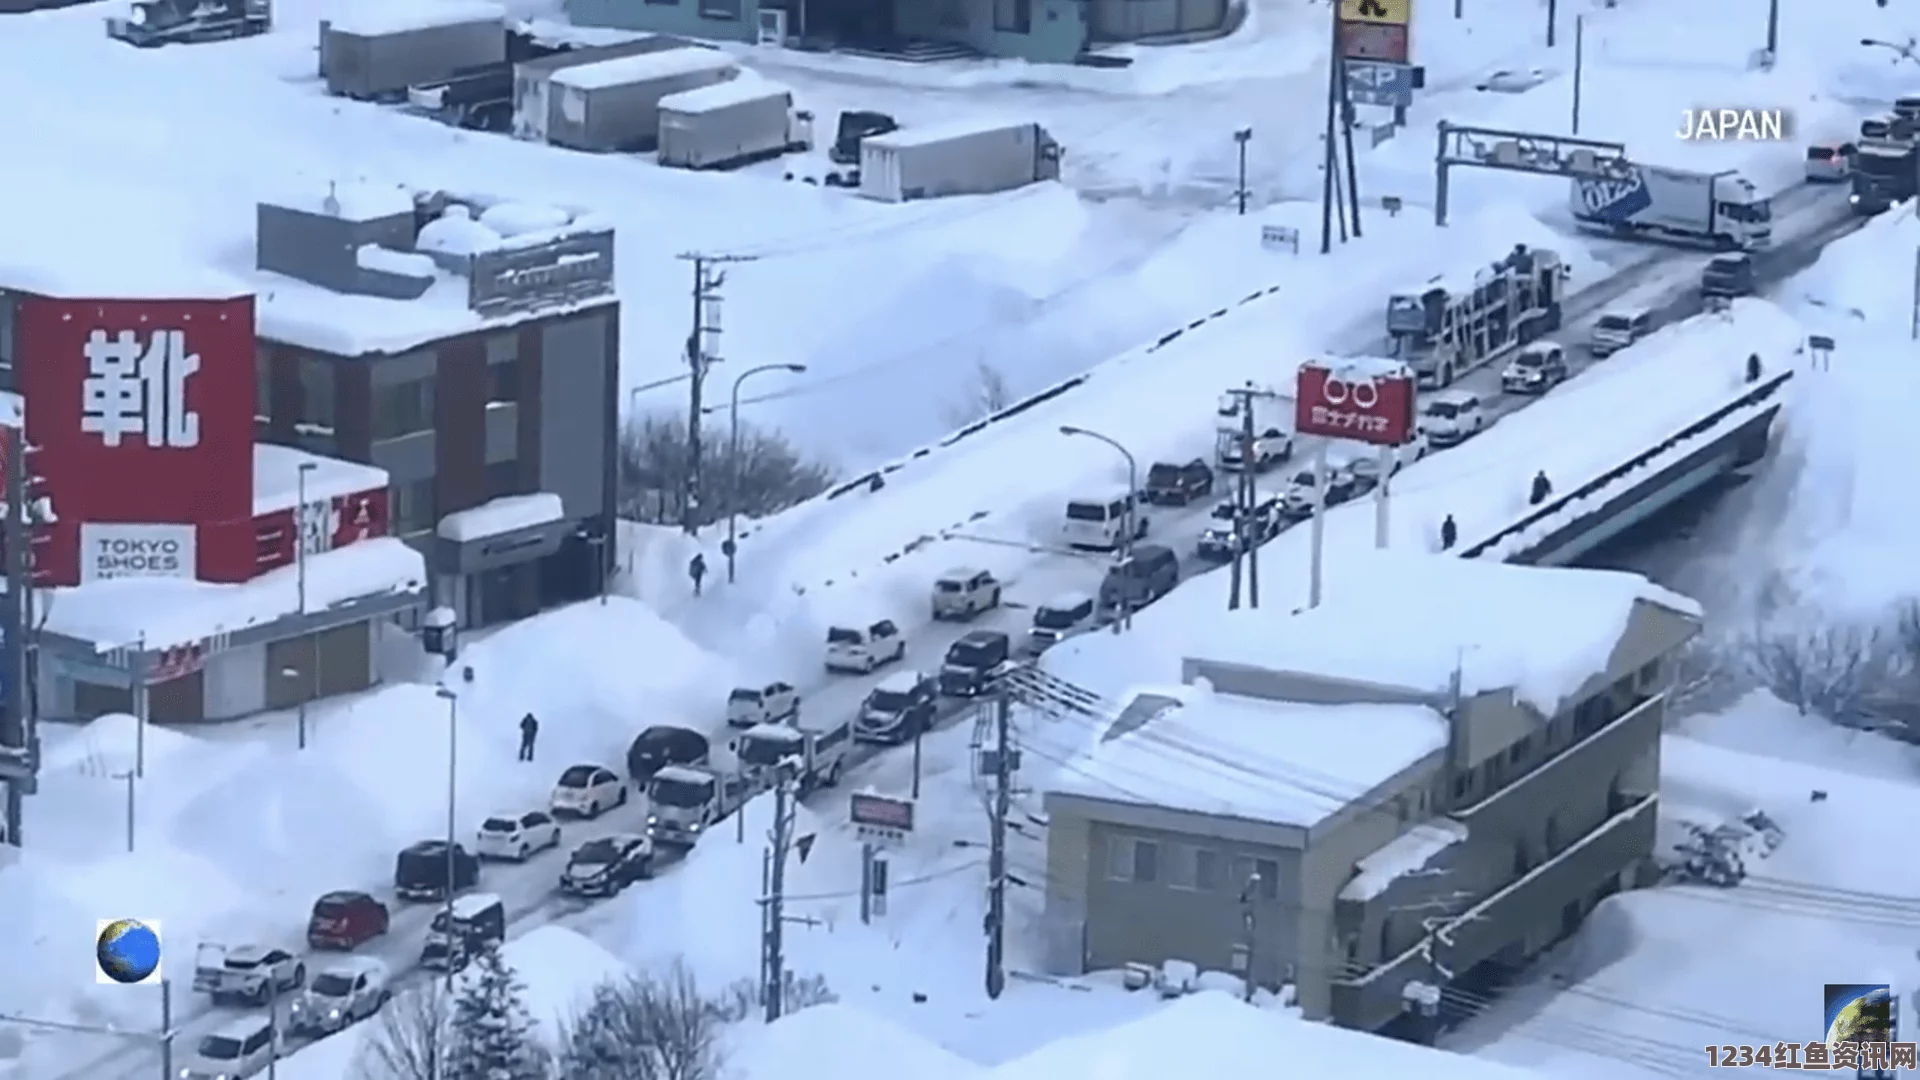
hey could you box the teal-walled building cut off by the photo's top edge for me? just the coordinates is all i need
[566,0,1240,63]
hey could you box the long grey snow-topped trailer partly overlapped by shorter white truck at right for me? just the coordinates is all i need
[537,48,739,152]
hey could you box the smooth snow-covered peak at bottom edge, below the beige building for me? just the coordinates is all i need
[987,990,1544,1080]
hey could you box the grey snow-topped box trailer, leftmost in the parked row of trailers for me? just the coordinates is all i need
[321,4,507,102]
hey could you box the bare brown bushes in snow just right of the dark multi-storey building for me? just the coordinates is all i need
[620,415,833,525]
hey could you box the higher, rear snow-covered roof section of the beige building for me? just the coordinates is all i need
[1190,552,1699,715]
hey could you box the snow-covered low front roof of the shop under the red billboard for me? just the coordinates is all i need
[44,536,426,651]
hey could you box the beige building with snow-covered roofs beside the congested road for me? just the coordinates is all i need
[1046,555,1699,1034]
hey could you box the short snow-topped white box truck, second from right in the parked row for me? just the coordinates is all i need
[660,75,814,169]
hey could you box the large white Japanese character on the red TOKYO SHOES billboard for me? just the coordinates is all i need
[81,331,200,450]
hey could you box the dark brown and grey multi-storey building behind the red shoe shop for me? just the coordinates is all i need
[253,190,620,626]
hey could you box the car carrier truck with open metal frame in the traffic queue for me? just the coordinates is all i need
[1386,244,1567,388]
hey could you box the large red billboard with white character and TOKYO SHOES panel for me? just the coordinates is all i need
[13,296,253,584]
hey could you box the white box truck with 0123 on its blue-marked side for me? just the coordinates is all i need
[1569,163,1774,252]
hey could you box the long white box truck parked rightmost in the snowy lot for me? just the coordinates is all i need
[860,121,1062,202]
